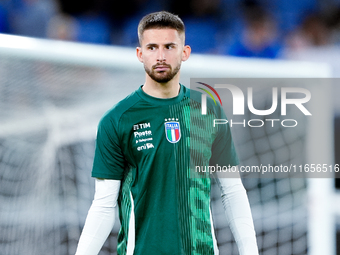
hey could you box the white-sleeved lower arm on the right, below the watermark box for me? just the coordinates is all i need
[216,169,259,255]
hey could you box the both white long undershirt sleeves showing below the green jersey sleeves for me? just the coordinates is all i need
[76,175,258,255]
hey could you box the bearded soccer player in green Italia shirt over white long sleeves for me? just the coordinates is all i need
[76,11,258,255]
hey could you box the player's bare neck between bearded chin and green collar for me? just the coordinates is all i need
[142,75,180,98]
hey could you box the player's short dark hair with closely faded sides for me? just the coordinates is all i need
[138,11,185,44]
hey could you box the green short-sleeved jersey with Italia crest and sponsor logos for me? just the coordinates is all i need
[92,85,238,255]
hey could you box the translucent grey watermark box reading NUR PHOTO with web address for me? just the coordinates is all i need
[190,78,339,178]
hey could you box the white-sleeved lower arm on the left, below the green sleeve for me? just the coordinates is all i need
[76,179,120,255]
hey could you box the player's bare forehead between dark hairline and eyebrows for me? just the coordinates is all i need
[141,28,183,45]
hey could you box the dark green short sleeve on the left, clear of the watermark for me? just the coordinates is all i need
[92,116,126,180]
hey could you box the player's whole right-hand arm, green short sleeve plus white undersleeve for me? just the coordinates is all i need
[209,102,258,255]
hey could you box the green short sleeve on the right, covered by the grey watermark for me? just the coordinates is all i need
[209,107,239,166]
